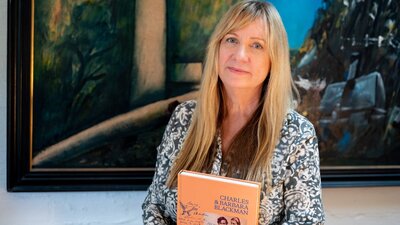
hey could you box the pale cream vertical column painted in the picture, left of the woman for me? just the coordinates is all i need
[131,0,166,103]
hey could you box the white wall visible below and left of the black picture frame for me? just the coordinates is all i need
[0,0,400,225]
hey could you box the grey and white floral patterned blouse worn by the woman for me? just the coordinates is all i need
[142,100,325,225]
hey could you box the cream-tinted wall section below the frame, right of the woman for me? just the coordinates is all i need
[322,187,400,225]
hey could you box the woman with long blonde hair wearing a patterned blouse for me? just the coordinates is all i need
[142,1,324,224]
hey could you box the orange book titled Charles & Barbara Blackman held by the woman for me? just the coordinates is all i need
[177,170,261,225]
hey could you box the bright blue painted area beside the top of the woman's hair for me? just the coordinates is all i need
[269,0,323,49]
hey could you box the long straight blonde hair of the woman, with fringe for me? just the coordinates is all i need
[167,1,294,187]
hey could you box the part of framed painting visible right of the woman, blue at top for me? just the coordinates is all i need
[272,0,400,186]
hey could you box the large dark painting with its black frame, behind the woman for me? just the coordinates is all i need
[7,0,400,191]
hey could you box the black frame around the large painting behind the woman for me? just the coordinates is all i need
[7,0,400,192]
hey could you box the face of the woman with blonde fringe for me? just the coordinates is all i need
[218,19,271,93]
